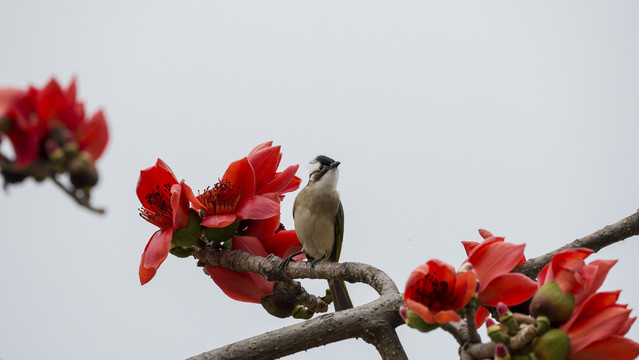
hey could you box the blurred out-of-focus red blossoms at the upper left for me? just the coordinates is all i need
[0,79,109,166]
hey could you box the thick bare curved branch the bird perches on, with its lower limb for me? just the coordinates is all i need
[191,249,407,360]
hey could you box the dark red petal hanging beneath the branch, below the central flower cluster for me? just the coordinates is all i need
[205,266,273,304]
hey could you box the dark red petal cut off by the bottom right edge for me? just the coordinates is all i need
[570,336,639,360]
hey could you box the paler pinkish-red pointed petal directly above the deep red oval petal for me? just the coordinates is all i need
[468,238,526,293]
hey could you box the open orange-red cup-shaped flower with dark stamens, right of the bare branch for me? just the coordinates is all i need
[404,260,477,324]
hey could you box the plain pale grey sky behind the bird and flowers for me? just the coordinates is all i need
[0,0,639,360]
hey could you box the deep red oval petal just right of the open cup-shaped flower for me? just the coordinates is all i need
[479,273,537,306]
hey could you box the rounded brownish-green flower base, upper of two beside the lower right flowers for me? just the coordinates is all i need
[530,280,575,325]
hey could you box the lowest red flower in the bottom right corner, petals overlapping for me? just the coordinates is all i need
[560,291,639,360]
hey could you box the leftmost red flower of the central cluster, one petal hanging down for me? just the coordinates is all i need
[136,159,189,285]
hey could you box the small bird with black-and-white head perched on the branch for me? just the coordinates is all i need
[293,155,353,311]
